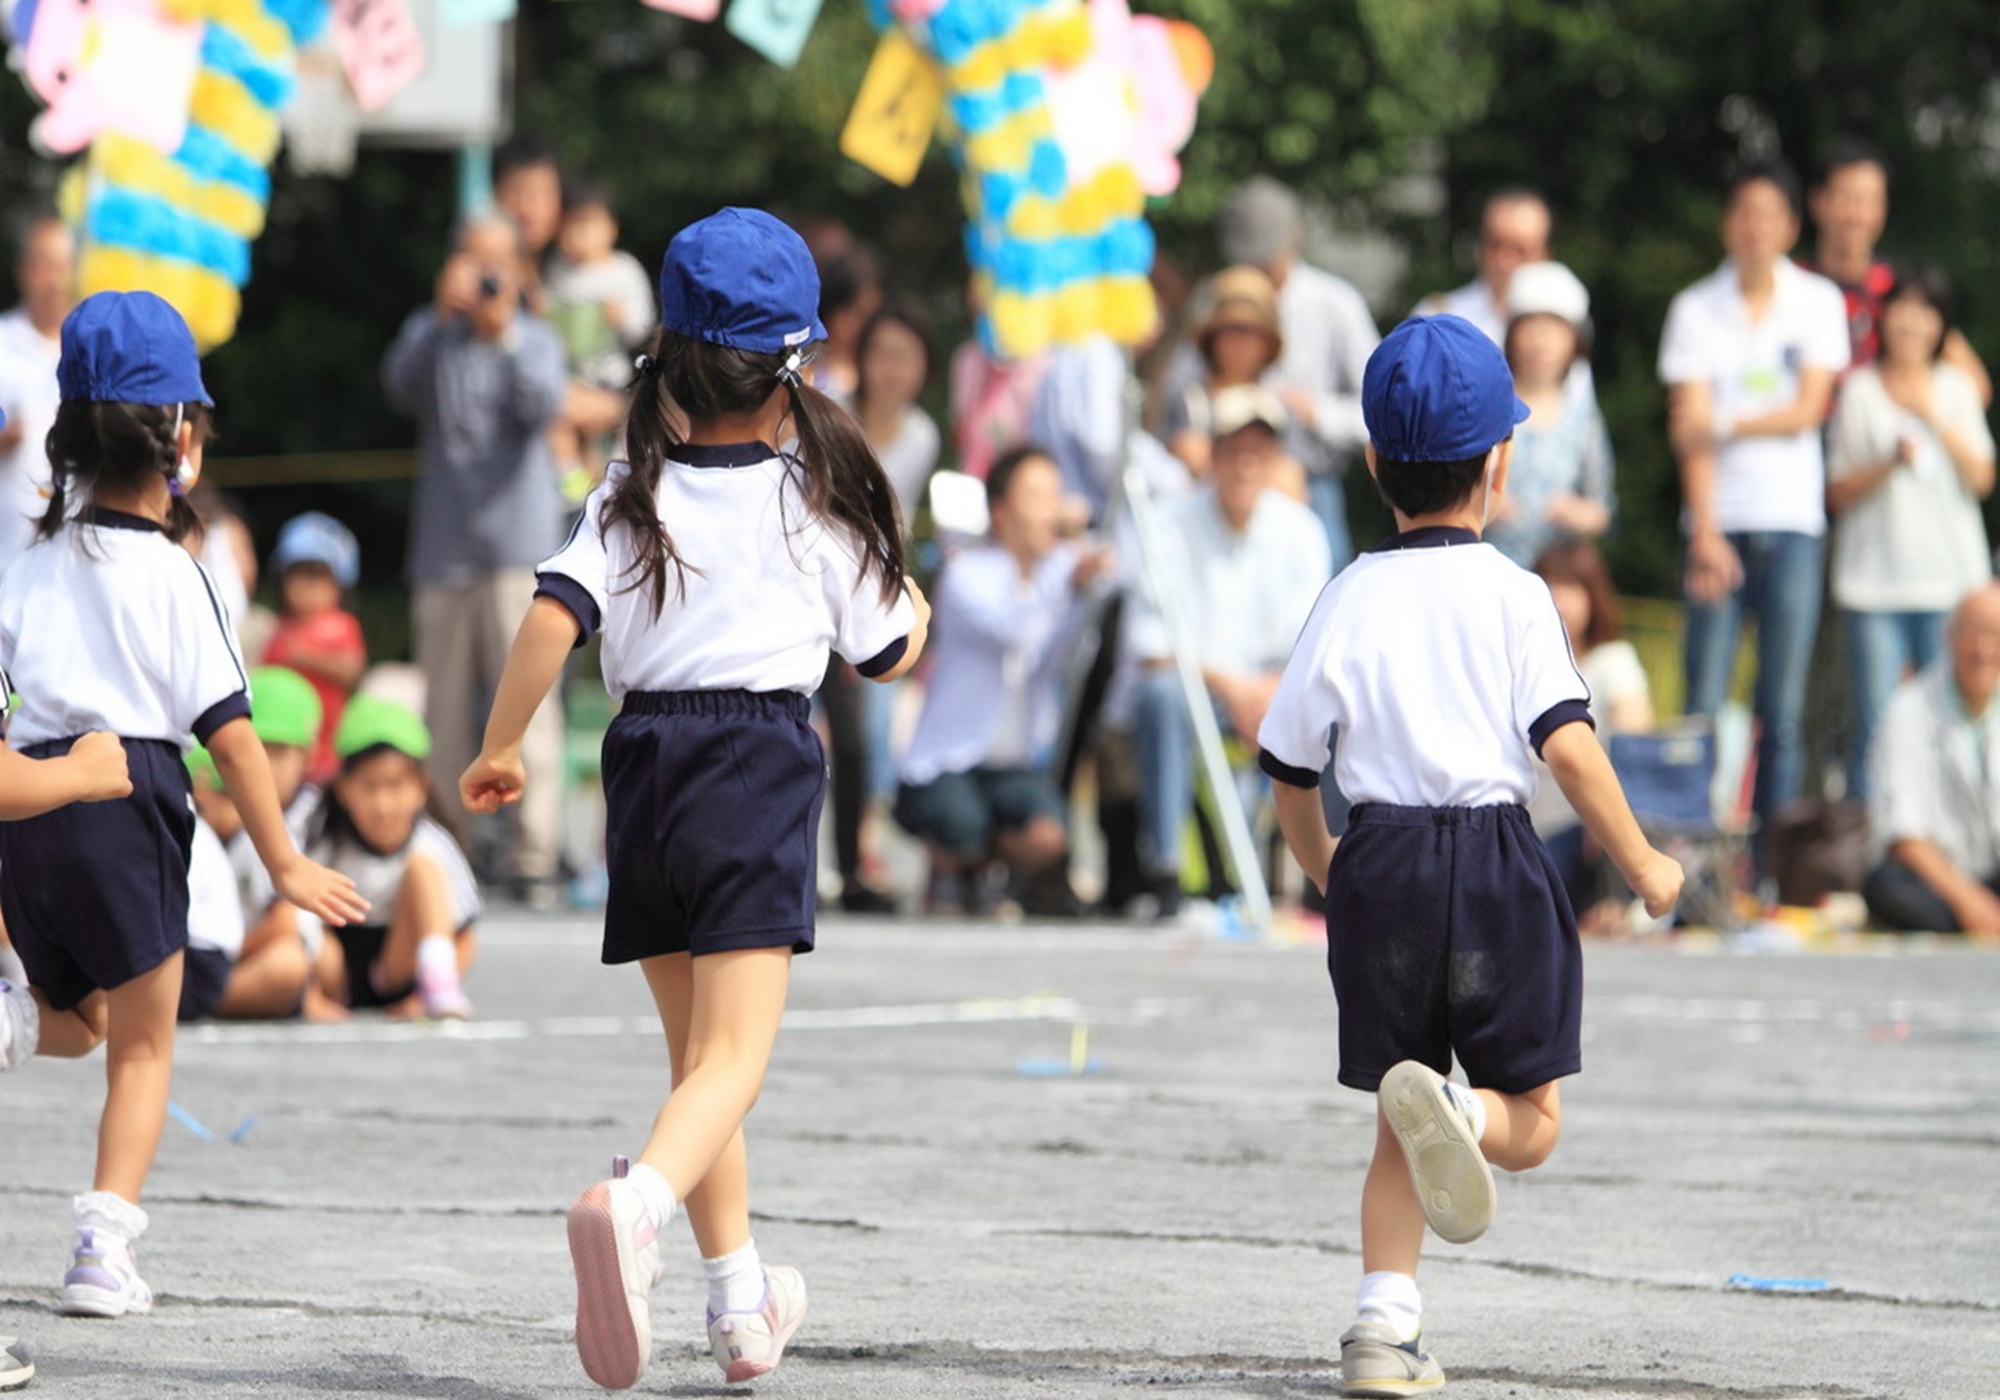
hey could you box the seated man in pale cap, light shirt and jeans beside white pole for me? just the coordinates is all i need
[1122,384,1334,914]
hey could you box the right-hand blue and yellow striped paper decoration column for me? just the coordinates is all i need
[870,0,1206,358]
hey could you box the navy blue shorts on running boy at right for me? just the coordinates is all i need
[1326,802,1584,1094]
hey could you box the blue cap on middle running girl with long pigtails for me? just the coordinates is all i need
[660,208,826,354]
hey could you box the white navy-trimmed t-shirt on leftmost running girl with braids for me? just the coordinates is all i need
[0,510,250,748]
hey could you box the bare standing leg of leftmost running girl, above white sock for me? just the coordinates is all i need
[96,952,182,1204]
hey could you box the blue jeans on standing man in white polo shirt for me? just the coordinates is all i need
[1688,530,1820,824]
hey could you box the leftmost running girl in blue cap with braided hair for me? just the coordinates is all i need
[0,292,366,1318]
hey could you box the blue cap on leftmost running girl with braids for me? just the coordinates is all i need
[56,292,216,404]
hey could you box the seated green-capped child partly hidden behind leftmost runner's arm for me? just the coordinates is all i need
[180,666,346,1022]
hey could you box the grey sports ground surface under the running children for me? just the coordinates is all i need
[0,914,2000,1400]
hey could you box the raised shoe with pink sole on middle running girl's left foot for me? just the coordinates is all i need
[570,1176,664,1390]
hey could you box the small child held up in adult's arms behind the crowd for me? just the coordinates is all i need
[542,180,658,492]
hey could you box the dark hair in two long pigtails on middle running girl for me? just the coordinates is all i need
[604,330,904,616]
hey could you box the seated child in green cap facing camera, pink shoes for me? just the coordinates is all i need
[308,694,480,1018]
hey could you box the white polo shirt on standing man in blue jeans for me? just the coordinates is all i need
[1660,258,1852,534]
